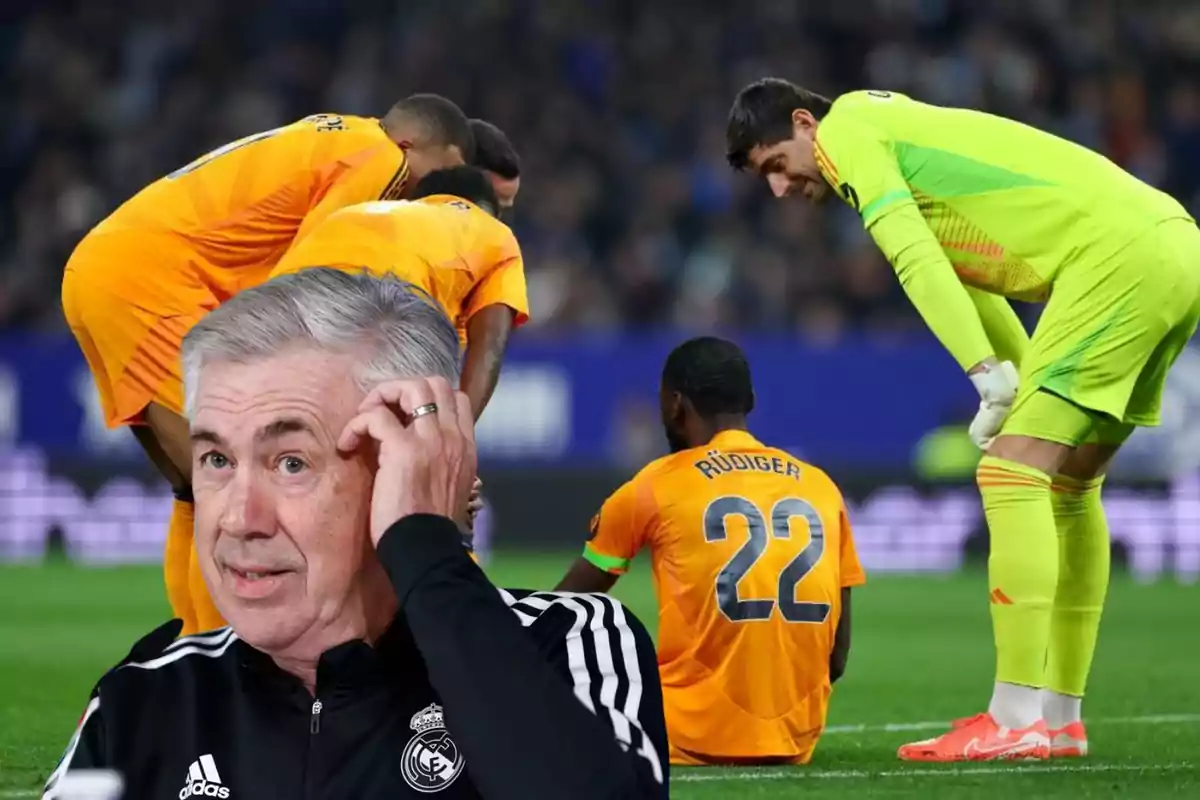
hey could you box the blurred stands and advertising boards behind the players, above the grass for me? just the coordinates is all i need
[0,0,1200,577]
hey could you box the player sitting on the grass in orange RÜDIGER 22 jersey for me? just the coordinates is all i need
[558,337,865,765]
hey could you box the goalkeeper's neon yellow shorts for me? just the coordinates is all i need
[1004,218,1200,434]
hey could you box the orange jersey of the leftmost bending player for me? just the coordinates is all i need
[95,114,408,280]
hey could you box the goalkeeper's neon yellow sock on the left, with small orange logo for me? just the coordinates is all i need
[976,456,1058,688]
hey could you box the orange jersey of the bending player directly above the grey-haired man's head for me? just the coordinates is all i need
[271,194,529,343]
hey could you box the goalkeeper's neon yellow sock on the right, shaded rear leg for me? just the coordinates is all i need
[1046,475,1111,697]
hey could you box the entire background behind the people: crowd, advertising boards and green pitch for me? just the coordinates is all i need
[0,0,1200,800]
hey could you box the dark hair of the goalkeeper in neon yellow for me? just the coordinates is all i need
[725,78,833,169]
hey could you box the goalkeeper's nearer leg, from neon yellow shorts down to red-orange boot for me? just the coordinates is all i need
[900,223,1200,760]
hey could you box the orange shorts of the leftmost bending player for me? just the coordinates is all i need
[62,231,265,427]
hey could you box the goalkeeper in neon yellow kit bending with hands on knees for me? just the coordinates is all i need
[728,79,1200,762]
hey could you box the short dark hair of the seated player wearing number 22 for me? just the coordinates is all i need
[662,336,754,417]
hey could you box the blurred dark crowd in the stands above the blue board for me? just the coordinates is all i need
[0,0,1200,337]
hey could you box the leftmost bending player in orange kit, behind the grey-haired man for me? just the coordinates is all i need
[62,95,474,634]
